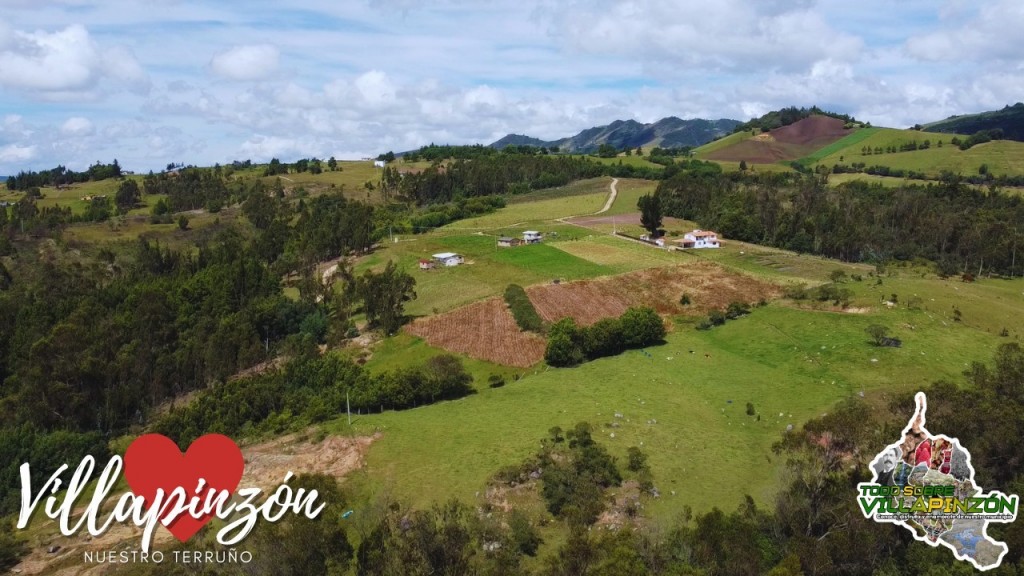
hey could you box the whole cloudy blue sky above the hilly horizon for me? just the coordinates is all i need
[0,0,1024,174]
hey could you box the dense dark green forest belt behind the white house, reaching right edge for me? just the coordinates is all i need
[655,164,1024,275]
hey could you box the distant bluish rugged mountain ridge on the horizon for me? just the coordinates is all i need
[489,116,739,153]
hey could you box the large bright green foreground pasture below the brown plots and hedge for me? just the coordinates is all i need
[329,293,1007,519]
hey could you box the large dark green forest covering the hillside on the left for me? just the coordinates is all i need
[0,175,425,512]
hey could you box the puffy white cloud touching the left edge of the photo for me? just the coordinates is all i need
[0,25,147,96]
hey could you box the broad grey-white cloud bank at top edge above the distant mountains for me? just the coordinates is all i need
[545,0,863,75]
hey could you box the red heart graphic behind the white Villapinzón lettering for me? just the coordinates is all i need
[124,434,246,542]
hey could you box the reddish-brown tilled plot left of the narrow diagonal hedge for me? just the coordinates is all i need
[406,298,545,368]
